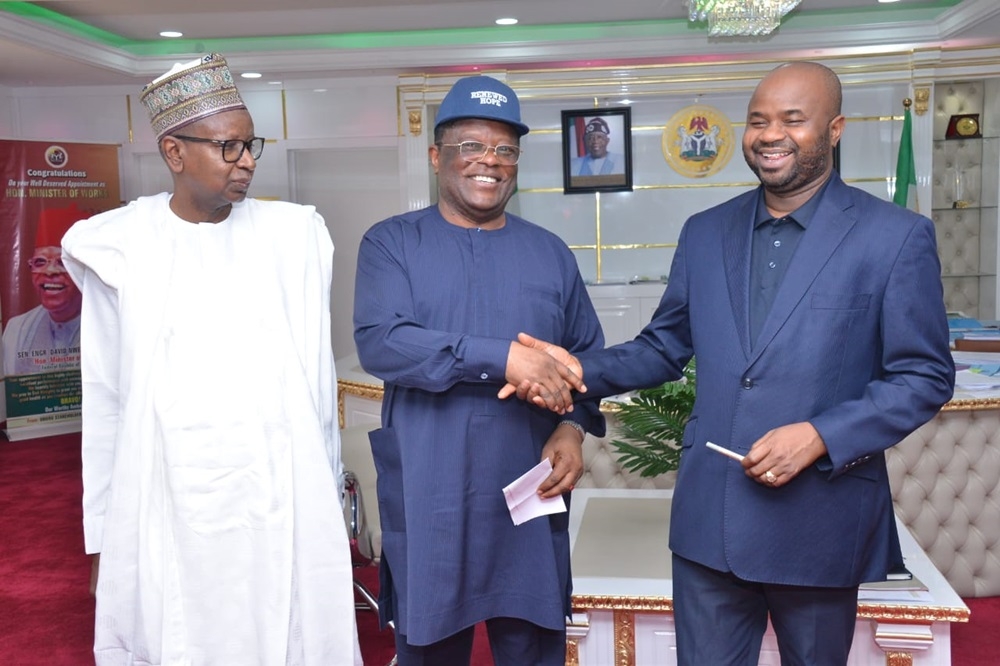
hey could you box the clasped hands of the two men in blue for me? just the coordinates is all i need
[497,333,587,414]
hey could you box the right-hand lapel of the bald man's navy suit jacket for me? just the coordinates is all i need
[747,174,857,362]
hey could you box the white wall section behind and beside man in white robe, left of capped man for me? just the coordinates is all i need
[0,72,404,357]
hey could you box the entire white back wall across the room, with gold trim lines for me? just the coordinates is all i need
[0,51,1000,356]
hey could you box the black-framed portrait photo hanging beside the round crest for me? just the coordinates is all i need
[562,106,632,194]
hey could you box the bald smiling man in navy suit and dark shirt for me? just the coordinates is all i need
[502,62,954,666]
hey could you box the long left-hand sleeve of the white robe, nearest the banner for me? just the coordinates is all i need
[63,218,121,553]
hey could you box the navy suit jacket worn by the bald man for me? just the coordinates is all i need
[580,173,955,587]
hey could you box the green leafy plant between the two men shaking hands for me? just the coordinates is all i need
[611,358,695,477]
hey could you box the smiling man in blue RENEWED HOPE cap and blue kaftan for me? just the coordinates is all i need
[354,76,604,666]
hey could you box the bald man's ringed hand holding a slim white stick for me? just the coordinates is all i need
[742,421,826,488]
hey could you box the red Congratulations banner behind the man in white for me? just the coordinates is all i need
[0,140,121,440]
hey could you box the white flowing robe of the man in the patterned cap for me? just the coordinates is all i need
[63,194,361,666]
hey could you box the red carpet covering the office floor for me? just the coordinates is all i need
[0,435,1000,666]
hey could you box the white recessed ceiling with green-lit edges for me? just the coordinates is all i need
[0,0,1000,88]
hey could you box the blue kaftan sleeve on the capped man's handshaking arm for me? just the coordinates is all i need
[354,220,511,392]
